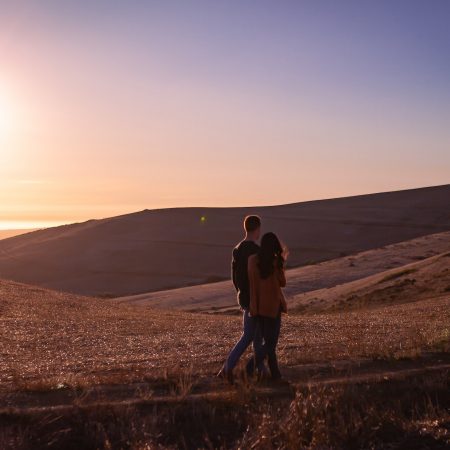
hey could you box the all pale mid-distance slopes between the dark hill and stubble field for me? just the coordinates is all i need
[113,231,450,313]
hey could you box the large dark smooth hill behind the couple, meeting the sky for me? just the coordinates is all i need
[0,185,450,296]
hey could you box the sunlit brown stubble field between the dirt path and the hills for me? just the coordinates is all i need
[0,281,450,390]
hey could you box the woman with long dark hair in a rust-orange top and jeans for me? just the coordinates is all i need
[248,233,287,380]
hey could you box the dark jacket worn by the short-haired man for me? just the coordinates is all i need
[231,241,259,309]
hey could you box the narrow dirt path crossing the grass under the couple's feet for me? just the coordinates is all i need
[0,353,450,416]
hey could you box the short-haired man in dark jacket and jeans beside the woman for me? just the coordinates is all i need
[218,216,261,383]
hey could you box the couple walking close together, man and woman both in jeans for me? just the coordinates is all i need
[219,216,287,384]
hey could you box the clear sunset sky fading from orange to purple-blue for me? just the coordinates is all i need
[0,0,450,229]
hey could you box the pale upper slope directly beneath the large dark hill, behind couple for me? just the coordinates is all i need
[113,231,450,312]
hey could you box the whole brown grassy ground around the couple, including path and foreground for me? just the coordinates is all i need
[0,255,450,449]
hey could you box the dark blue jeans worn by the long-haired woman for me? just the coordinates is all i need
[255,314,281,379]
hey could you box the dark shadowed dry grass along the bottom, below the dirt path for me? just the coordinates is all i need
[0,371,450,450]
